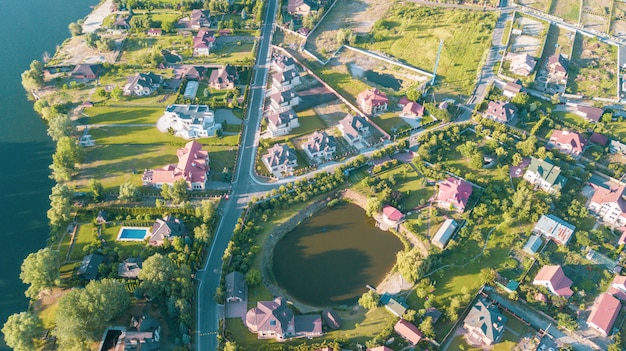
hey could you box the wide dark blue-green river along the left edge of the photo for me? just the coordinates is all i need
[0,0,97,351]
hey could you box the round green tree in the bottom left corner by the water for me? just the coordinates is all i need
[2,312,43,351]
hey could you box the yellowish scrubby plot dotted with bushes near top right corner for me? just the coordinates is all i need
[567,34,618,99]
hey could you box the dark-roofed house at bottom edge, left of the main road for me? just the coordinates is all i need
[122,316,161,351]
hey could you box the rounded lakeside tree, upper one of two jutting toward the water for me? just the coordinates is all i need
[20,248,61,299]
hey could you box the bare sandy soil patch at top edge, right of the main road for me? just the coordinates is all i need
[307,0,393,55]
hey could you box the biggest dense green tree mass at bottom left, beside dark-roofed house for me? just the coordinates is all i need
[52,279,130,350]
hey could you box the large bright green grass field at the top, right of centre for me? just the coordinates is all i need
[359,4,496,95]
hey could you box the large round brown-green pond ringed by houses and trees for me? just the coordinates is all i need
[272,203,403,307]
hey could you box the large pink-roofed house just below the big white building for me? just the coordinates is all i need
[142,141,211,190]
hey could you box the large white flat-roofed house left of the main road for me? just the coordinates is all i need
[162,105,222,139]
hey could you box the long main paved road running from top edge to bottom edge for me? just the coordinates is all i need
[196,0,276,351]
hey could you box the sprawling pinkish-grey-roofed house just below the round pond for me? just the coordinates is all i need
[244,297,322,340]
